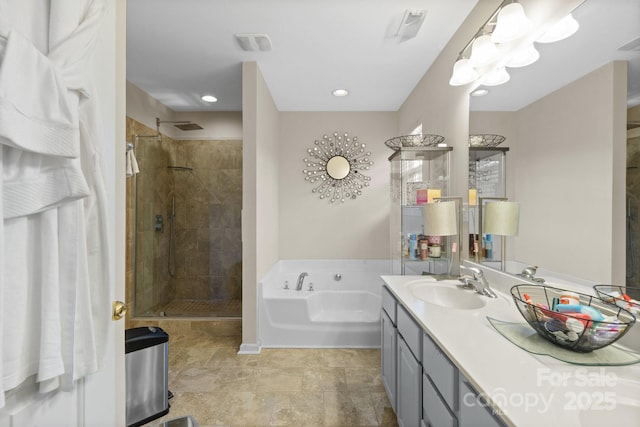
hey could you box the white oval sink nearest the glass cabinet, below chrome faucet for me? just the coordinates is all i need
[407,280,487,310]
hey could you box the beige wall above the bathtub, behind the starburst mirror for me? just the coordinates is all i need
[279,112,397,259]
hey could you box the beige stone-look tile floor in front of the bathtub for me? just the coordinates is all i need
[146,331,397,427]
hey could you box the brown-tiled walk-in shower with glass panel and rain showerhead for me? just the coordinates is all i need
[127,118,242,318]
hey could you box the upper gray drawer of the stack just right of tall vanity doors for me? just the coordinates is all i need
[422,334,458,411]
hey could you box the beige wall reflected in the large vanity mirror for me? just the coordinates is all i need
[513,63,626,283]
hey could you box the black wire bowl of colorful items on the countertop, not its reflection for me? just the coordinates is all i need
[511,285,636,353]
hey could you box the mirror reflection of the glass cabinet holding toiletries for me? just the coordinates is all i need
[468,147,509,267]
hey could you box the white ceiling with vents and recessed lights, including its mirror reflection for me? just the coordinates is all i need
[127,0,640,111]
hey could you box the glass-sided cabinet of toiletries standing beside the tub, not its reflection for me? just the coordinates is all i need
[389,147,453,275]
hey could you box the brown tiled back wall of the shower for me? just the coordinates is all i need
[172,140,242,300]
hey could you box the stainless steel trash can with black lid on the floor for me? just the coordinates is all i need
[125,327,169,427]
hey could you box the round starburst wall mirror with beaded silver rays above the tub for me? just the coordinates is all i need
[302,132,373,203]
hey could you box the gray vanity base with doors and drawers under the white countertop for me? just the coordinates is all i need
[381,286,505,427]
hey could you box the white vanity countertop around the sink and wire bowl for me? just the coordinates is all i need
[382,270,640,427]
